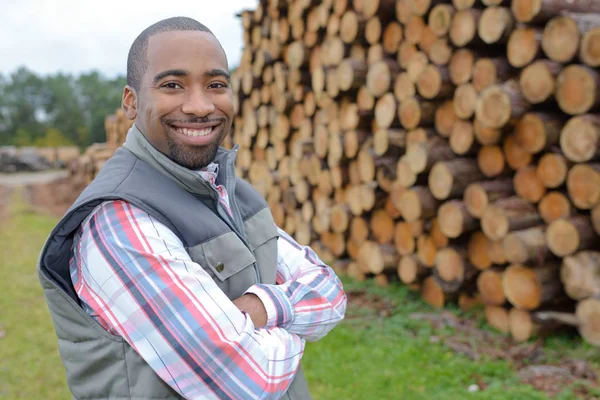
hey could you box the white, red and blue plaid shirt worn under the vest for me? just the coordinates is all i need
[70,164,346,399]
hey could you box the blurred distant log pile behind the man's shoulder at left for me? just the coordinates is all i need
[67,108,133,189]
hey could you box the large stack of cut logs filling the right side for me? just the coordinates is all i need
[229,0,600,344]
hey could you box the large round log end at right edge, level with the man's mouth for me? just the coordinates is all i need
[560,115,600,162]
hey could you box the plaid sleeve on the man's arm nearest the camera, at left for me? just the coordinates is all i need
[71,201,305,399]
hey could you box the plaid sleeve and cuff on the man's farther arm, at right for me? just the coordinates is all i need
[247,228,347,341]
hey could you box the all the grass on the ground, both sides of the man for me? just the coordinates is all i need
[0,189,600,400]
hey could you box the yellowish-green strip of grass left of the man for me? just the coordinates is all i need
[0,193,70,400]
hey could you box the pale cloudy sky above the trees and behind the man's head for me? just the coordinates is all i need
[0,0,258,77]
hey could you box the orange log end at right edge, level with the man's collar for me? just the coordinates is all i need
[567,164,600,210]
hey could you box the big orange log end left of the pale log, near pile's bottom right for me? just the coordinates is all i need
[502,264,562,310]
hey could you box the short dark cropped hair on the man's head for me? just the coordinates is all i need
[127,17,214,90]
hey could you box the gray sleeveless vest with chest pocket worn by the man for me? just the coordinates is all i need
[38,148,310,400]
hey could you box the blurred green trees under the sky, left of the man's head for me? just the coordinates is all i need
[0,67,126,147]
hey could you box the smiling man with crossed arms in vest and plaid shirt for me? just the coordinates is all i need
[39,17,346,399]
